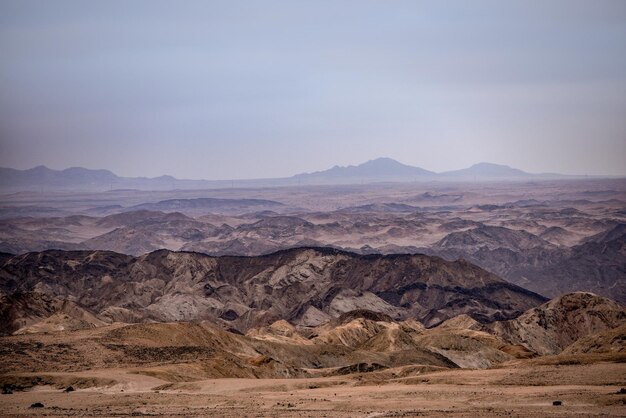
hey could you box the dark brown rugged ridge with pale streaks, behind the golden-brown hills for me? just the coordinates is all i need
[0,248,545,331]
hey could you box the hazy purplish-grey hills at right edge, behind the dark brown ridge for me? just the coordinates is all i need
[421,224,626,303]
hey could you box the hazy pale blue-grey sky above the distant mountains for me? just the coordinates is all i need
[0,0,626,179]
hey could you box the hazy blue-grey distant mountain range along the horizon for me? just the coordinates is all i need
[0,158,596,192]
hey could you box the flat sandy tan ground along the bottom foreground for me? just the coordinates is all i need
[0,363,626,418]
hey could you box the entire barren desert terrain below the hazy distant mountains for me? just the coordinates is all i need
[0,179,626,418]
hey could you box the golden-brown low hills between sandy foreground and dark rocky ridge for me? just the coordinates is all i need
[0,293,626,382]
